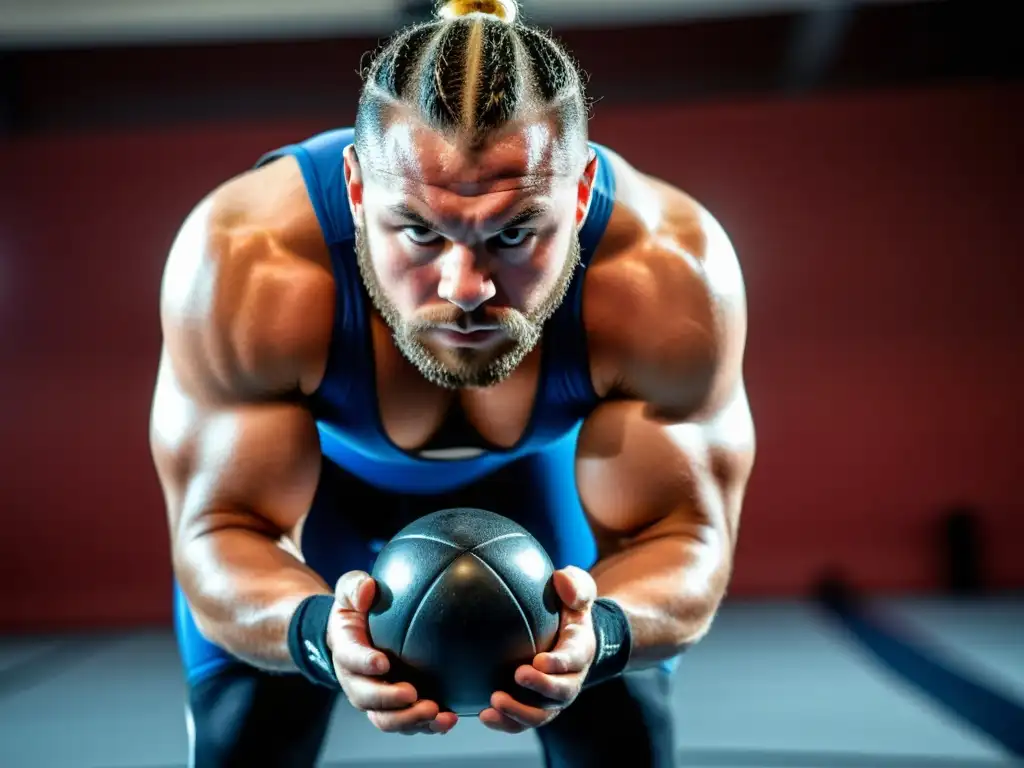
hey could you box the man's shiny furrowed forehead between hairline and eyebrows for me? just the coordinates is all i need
[372,118,572,196]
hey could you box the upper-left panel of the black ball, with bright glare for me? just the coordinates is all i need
[369,538,461,653]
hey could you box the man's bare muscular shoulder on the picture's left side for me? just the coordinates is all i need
[160,158,334,403]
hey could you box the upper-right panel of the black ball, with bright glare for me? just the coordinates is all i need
[473,536,561,653]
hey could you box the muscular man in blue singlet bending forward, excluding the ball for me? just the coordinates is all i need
[152,0,754,768]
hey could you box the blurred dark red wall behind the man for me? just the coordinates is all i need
[0,81,1024,629]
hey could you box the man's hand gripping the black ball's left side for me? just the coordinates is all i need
[327,570,459,735]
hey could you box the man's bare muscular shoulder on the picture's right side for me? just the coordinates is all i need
[585,155,746,416]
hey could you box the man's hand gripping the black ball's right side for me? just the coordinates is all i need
[480,566,597,733]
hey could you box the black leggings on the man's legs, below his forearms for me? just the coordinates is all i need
[188,665,675,768]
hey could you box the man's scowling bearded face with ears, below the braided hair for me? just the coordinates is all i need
[345,120,596,388]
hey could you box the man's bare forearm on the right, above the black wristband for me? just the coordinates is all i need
[591,536,729,668]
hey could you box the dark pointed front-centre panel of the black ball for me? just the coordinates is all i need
[401,553,535,717]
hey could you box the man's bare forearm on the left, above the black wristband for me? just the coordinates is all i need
[174,525,332,672]
